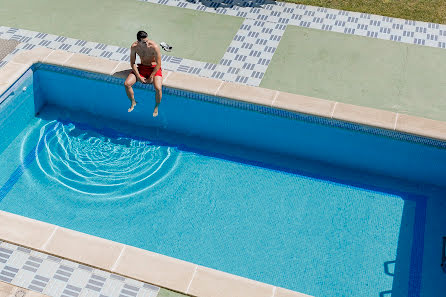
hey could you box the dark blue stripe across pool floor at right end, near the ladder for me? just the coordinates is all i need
[408,196,427,297]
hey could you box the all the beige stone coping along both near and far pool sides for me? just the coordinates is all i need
[0,48,446,297]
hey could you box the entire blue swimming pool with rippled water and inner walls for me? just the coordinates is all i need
[0,64,446,296]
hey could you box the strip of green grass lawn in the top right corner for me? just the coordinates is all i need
[282,0,446,24]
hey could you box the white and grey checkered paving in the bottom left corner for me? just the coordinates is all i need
[0,241,160,297]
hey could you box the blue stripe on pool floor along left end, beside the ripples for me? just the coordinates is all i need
[0,123,59,202]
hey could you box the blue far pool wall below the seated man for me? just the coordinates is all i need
[29,64,446,186]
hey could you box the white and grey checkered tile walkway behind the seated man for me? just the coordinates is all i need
[0,0,446,86]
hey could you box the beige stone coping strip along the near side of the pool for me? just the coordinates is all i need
[0,211,310,297]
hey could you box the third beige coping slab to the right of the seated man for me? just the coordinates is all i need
[272,92,335,118]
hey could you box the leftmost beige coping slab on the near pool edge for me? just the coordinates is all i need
[0,211,56,249]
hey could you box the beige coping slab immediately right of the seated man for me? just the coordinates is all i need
[164,72,221,95]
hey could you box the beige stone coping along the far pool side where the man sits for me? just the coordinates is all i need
[0,47,446,141]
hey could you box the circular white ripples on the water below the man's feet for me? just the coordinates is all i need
[26,121,178,199]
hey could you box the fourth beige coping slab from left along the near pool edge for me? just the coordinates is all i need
[186,266,274,297]
